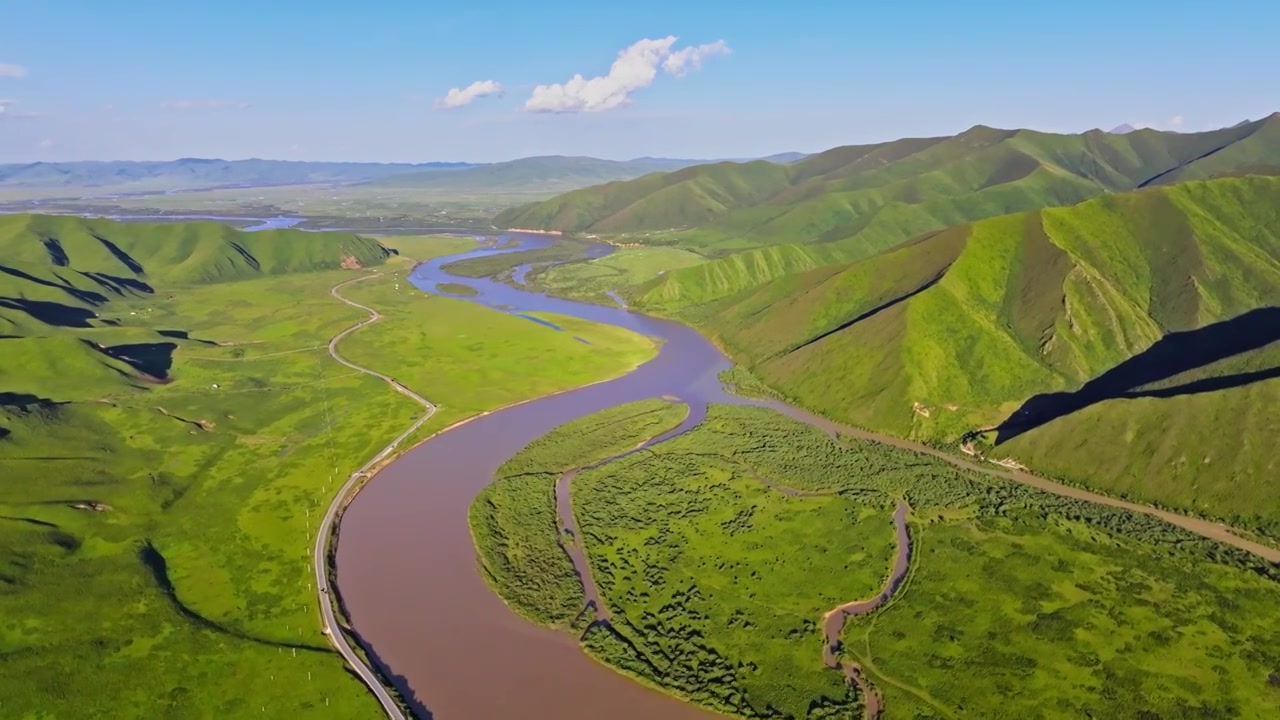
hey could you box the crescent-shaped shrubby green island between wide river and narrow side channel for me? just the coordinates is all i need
[470,400,687,626]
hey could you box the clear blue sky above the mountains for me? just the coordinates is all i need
[0,0,1280,163]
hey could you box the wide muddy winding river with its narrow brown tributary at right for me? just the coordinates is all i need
[337,236,1267,720]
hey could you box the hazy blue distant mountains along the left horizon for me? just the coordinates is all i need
[0,158,471,192]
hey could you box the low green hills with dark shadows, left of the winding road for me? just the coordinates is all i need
[0,215,392,340]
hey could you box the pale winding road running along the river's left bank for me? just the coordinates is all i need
[312,274,435,720]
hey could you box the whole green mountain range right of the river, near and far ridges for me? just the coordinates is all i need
[495,114,1280,538]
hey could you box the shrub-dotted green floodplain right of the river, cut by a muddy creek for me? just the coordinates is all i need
[476,406,1280,719]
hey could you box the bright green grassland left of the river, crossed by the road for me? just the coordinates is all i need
[0,218,653,717]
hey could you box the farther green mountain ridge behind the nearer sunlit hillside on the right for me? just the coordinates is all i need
[495,114,1280,310]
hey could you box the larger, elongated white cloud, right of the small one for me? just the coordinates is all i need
[525,35,730,113]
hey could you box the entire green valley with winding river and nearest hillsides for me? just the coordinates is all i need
[0,121,1280,720]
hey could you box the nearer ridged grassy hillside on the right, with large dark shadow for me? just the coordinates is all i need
[690,177,1280,530]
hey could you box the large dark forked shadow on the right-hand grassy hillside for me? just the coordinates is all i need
[996,307,1280,445]
